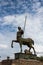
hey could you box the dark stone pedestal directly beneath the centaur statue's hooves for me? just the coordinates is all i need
[15,53,36,59]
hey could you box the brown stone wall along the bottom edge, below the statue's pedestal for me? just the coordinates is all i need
[12,59,43,65]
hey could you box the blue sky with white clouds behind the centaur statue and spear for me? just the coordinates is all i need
[0,0,43,59]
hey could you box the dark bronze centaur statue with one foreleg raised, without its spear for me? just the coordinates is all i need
[11,27,36,54]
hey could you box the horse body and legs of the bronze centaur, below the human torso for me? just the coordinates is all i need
[11,38,36,54]
